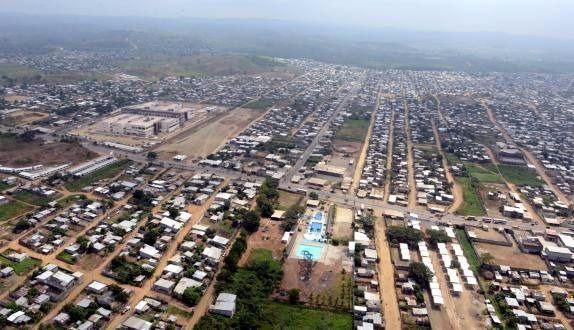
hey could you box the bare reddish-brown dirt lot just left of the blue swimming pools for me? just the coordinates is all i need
[239,219,285,266]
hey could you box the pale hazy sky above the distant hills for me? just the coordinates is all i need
[0,0,574,38]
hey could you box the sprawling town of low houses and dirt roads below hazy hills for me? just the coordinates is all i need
[0,1,574,330]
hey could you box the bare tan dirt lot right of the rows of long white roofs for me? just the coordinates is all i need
[474,243,548,270]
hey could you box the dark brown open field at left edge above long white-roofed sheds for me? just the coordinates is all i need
[0,134,96,167]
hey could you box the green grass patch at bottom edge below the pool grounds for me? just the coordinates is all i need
[260,302,353,330]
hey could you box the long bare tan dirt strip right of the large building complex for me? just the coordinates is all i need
[157,108,261,160]
